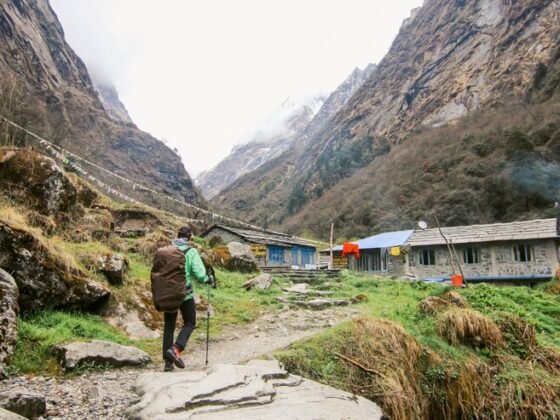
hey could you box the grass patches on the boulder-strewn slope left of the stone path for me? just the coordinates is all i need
[0,194,280,374]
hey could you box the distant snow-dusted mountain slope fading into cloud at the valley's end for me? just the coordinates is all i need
[195,96,325,199]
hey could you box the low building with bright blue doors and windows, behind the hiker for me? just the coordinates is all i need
[200,224,317,268]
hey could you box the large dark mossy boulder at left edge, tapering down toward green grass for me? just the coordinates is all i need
[0,221,110,312]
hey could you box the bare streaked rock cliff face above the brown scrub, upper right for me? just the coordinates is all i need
[298,0,560,197]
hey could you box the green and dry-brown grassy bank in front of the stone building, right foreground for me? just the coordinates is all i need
[277,274,560,419]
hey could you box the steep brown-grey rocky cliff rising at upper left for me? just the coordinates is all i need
[0,0,204,208]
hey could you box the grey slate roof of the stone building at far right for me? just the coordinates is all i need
[406,219,560,246]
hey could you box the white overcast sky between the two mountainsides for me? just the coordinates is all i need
[51,0,422,176]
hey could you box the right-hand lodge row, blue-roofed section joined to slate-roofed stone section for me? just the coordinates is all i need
[321,219,560,283]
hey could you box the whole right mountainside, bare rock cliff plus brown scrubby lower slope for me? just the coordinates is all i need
[213,0,560,238]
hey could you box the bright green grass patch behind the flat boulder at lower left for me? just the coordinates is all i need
[10,311,134,374]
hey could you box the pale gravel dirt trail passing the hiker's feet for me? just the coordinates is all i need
[2,307,358,419]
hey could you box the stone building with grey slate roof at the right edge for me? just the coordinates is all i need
[405,219,560,282]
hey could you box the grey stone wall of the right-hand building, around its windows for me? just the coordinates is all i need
[408,239,559,278]
